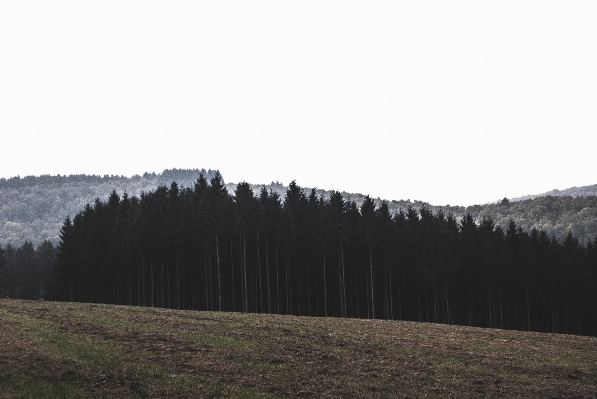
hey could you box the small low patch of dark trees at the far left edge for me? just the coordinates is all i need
[0,241,56,299]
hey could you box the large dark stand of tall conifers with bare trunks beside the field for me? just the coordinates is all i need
[50,173,597,336]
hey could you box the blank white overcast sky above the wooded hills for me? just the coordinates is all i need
[0,1,597,205]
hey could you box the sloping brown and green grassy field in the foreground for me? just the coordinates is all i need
[0,299,597,398]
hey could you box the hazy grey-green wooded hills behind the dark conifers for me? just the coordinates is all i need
[0,169,597,246]
